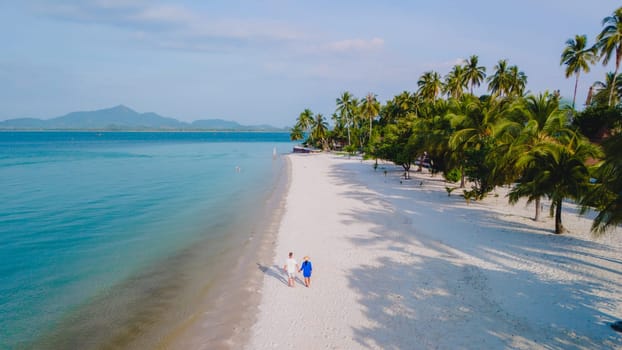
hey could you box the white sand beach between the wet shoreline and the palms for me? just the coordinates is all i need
[246,154,622,349]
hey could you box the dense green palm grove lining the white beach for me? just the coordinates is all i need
[291,7,622,233]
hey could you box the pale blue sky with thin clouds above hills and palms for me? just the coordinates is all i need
[0,0,620,127]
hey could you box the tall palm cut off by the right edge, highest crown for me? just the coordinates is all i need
[596,7,622,106]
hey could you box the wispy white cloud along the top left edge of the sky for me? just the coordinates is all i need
[37,0,304,51]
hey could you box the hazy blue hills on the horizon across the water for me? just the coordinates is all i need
[0,105,284,131]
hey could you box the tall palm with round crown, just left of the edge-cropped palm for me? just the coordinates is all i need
[559,35,596,108]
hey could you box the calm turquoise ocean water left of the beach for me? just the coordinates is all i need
[0,132,292,349]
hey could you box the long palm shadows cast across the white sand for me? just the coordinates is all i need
[332,159,622,349]
